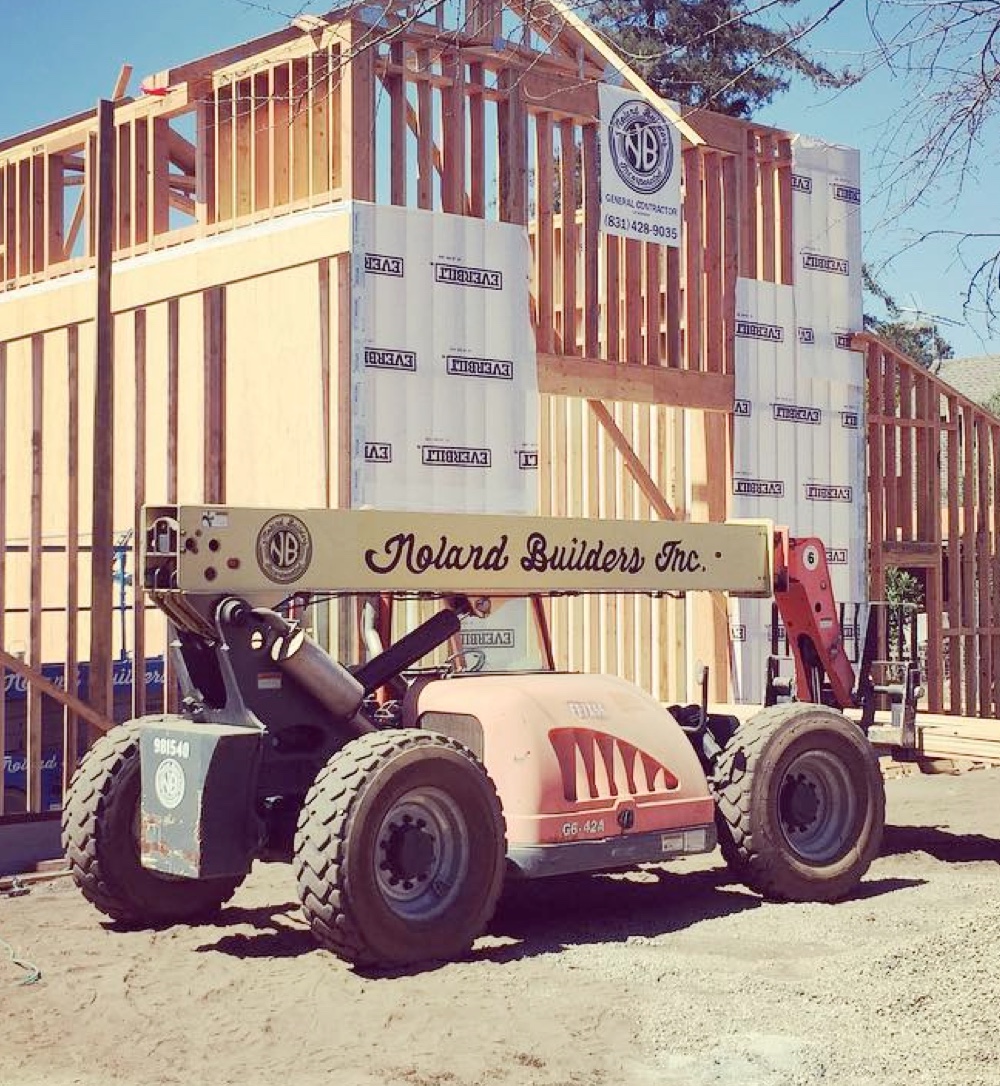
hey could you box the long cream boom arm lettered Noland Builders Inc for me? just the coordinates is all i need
[143,505,772,602]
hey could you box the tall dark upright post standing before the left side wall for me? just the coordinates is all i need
[87,99,115,717]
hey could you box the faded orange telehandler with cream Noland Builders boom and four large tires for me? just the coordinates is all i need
[63,505,916,968]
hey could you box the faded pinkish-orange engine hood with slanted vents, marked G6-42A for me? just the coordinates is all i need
[416,673,716,875]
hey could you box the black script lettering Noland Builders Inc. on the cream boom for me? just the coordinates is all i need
[365,531,707,574]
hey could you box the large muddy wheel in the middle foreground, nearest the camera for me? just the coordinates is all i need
[295,729,506,969]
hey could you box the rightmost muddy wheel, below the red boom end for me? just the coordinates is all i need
[711,704,885,901]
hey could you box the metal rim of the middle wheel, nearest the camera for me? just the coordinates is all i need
[375,787,469,920]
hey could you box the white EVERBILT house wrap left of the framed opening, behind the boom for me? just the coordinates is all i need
[351,203,539,667]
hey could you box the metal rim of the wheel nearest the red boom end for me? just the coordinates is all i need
[777,750,858,863]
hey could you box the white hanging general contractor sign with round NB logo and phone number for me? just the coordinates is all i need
[598,84,681,245]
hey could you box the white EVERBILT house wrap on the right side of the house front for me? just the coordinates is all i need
[731,138,868,703]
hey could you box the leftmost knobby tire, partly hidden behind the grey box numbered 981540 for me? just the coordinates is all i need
[62,720,243,927]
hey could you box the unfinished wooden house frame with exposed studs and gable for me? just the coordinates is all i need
[0,0,1000,812]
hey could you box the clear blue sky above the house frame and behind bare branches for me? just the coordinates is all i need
[0,0,1000,356]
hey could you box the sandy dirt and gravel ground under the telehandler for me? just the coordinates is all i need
[0,770,1000,1086]
